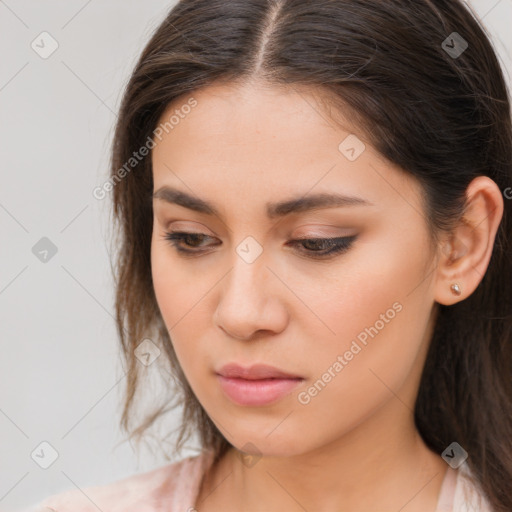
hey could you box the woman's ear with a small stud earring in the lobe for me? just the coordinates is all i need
[434,176,504,305]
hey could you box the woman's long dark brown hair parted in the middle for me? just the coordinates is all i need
[106,0,512,512]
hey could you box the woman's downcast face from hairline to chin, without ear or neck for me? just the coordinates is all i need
[151,85,435,455]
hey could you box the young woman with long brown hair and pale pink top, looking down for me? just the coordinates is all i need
[25,0,512,512]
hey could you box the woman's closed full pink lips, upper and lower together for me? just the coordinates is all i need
[217,363,304,406]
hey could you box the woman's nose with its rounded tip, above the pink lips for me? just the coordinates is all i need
[214,257,288,341]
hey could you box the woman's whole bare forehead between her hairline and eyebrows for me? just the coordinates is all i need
[152,84,424,218]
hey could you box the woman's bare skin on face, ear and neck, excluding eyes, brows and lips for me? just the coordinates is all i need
[151,83,503,512]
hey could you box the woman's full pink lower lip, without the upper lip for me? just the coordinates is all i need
[217,375,304,405]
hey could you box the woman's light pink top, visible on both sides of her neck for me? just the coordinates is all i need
[21,453,491,512]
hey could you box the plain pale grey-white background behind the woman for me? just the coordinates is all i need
[0,0,512,511]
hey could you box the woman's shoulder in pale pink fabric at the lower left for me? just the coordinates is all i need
[21,452,212,512]
